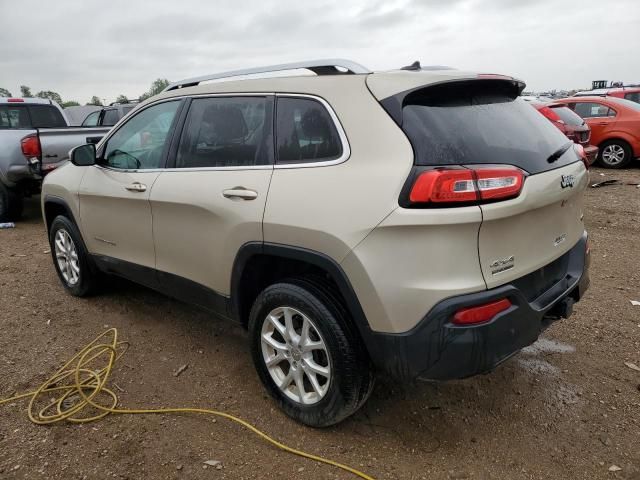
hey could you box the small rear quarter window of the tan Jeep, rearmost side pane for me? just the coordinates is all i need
[276,97,342,164]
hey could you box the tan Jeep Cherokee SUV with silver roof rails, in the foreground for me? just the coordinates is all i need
[42,60,588,426]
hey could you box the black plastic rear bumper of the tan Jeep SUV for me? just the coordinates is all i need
[368,233,589,380]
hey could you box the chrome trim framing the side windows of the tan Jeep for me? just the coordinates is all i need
[95,92,351,173]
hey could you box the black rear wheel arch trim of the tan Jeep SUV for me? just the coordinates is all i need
[229,242,372,350]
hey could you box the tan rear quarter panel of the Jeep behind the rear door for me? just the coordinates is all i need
[264,75,413,262]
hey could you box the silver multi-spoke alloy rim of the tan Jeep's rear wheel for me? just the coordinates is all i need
[260,307,331,405]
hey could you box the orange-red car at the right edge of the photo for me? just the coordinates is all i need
[553,97,640,168]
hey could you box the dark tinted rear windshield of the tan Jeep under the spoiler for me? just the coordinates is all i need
[402,80,577,173]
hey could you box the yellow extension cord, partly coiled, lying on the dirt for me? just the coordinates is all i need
[0,328,374,480]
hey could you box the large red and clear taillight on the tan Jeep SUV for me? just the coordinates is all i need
[409,166,524,205]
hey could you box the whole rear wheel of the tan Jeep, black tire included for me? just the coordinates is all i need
[249,279,375,427]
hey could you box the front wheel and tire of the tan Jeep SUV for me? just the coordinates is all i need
[49,215,98,297]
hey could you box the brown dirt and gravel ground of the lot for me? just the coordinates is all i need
[0,166,640,480]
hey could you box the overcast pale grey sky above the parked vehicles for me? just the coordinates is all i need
[0,0,640,103]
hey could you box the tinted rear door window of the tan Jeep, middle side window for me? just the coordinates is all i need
[176,96,273,168]
